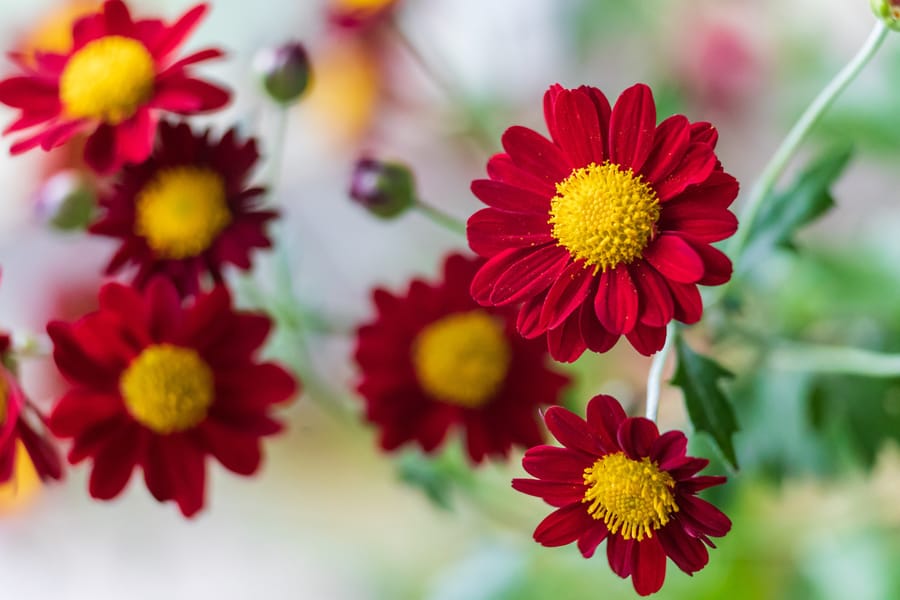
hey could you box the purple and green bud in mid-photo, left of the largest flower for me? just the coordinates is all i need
[350,158,416,219]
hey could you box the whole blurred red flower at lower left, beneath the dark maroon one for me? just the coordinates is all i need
[47,278,297,516]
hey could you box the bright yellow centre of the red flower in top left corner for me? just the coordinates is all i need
[59,35,156,125]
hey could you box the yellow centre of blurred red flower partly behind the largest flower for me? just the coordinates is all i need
[412,310,511,408]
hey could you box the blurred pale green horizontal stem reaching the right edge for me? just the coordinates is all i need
[767,344,900,377]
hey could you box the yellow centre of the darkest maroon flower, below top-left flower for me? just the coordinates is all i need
[134,167,231,260]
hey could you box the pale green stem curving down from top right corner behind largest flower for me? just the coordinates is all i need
[719,21,889,270]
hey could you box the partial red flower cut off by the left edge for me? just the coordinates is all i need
[0,334,62,483]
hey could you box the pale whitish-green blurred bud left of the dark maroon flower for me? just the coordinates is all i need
[36,170,97,231]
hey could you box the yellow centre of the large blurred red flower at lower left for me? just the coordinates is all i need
[119,344,215,435]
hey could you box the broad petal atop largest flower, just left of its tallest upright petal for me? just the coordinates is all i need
[553,90,605,168]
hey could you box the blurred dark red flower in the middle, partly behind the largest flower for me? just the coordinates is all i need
[356,254,568,463]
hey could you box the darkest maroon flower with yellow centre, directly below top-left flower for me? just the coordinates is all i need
[90,123,277,294]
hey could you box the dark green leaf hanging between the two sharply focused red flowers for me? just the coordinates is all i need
[672,335,738,468]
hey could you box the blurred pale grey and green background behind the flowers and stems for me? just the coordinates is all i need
[0,0,900,600]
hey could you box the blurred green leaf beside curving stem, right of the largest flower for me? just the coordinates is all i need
[742,146,853,265]
